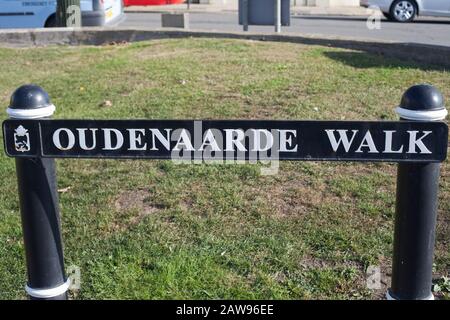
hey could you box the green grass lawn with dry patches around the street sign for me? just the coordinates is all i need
[0,39,450,299]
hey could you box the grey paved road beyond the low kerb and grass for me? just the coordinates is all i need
[121,12,450,46]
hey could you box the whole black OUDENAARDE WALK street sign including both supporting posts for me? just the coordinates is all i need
[3,85,448,300]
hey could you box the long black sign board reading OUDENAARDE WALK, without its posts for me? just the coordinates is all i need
[3,119,448,162]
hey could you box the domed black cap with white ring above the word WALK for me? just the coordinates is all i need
[396,84,448,121]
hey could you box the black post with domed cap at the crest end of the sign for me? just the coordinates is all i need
[7,85,69,300]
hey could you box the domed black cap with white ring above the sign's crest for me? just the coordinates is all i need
[6,84,55,119]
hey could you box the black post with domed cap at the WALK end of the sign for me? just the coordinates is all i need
[386,84,447,300]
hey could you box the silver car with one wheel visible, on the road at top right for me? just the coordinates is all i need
[360,0,450,22]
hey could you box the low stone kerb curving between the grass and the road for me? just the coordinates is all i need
[0,27,450,68]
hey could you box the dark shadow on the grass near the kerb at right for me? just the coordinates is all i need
[323,51,449,71]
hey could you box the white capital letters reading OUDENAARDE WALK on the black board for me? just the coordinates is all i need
[47,127,433,157]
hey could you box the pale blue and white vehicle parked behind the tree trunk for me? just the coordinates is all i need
[0,0,124,28]
